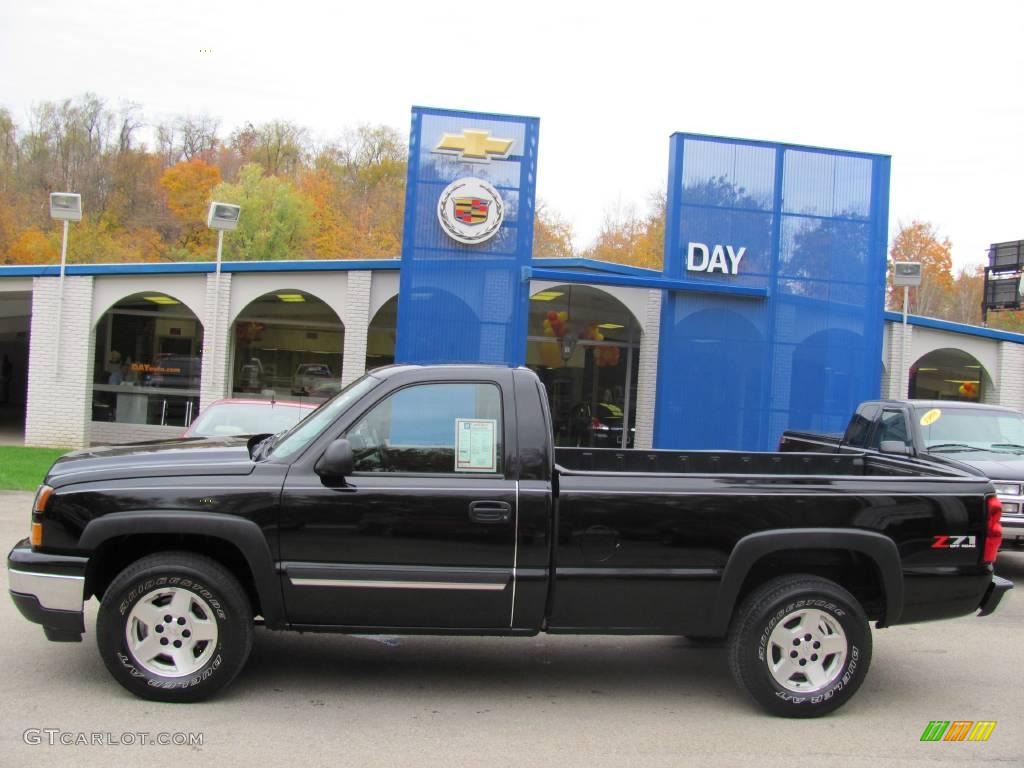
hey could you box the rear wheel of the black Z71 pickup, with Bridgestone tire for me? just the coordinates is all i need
[728,575,871,718]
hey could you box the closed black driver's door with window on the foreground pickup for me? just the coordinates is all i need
[281,381,517,631]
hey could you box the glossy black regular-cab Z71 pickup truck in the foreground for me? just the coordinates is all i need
[8,366,1013,717]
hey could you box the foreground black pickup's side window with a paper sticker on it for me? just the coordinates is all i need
[346,384,504,474]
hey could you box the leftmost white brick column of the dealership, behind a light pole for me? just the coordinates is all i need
[25,276,96,449]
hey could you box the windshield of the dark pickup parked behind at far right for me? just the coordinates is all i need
[914,407,1024,452]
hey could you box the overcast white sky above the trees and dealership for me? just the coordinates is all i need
[0,0,1024,265]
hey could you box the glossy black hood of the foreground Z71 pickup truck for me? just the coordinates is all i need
[45,437,254,487]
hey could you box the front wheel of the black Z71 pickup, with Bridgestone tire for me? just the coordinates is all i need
[96,552,253,702]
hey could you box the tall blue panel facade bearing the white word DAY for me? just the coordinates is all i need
[654,134,889,451]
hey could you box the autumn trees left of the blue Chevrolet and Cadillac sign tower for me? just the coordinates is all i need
[0,94,415,263]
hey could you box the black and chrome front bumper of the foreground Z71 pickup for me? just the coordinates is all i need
[7,539,87,642]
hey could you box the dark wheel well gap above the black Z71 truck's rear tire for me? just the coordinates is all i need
[736,549,886,622]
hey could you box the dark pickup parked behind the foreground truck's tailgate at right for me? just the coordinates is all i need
[778,400,1024,547]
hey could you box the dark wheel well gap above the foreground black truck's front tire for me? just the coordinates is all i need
[85,534,262,614]
